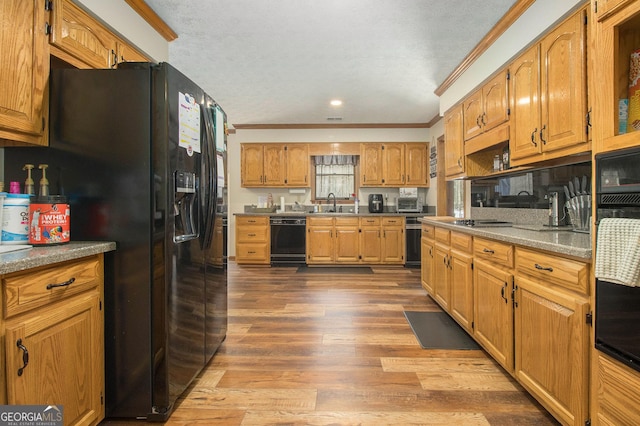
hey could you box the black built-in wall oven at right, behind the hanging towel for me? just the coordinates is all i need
[595,148,640,371]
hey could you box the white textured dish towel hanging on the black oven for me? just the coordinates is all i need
[595,218,640,287]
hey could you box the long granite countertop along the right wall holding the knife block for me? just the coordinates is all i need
[419,217,592,261]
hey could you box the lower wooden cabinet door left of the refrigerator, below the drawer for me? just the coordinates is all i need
[5,291,104,425]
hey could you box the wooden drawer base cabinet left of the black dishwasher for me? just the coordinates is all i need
[236,216,271,265]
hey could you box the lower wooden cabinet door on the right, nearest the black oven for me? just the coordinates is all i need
[515,276,589,425]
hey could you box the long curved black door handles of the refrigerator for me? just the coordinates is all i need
[200,106,217,249]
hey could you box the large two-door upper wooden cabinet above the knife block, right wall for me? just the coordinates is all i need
[509,10,590,166]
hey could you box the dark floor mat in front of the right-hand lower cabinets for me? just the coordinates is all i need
[404,311,480,349]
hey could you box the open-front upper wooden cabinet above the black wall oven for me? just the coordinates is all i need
[593,0,640,152]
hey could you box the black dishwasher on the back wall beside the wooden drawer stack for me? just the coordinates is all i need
[270,216,307,266]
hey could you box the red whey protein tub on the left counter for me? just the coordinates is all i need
[29,195,71,245]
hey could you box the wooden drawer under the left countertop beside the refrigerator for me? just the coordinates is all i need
[2,256,103,318]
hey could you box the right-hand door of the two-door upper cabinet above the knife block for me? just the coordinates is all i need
[540,13,587,152]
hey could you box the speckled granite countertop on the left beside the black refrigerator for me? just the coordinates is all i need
[0,241,116,274]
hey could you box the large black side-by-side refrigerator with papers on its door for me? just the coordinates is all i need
[5,63,227,421]
